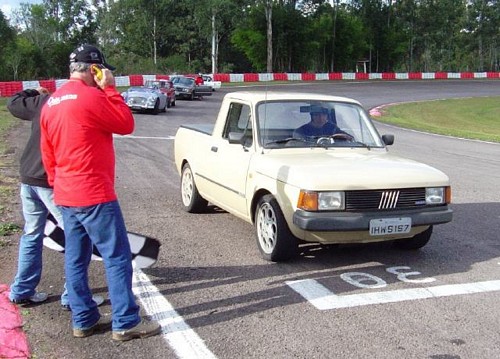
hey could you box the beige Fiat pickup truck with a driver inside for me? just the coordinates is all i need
[175,92,452,261]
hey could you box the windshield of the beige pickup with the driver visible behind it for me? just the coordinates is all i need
[257,101,384,148]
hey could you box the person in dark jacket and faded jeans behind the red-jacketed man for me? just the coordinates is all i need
[7,87,104,309]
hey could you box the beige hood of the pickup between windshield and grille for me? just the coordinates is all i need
[255,149,449,190]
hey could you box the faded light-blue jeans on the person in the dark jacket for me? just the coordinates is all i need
[10,183,63,300]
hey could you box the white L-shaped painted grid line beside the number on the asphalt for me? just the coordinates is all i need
[286,279,500,310]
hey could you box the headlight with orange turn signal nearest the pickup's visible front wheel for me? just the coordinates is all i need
[297,190,345,211]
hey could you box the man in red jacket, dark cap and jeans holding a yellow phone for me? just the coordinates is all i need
[41,44,161,341]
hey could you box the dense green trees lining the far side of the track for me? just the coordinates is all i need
[0,0,500,81]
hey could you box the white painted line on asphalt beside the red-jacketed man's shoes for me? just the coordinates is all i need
[132,269,217,359]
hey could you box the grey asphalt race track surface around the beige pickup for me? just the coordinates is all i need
[3,80,500,359]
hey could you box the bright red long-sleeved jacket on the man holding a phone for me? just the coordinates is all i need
[40,79,134,207]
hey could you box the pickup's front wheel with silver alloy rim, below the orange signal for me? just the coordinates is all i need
[255,195,299,262]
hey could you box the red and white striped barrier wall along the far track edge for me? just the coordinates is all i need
[0,72,500,97]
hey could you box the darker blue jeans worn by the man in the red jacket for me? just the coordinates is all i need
[59,201,141,330]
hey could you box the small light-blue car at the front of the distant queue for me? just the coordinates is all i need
[122,86,167,115]
